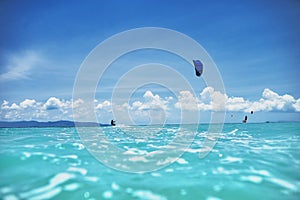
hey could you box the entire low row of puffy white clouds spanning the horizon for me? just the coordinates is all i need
[0,87,300,123]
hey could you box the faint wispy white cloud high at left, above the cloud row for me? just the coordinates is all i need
[0,51,42,81]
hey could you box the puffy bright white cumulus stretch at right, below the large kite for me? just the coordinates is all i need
[174,87,300,112]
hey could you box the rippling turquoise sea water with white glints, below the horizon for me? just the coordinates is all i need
[0,123,300,200]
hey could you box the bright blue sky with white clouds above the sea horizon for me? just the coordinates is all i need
[0,0,300,124]
